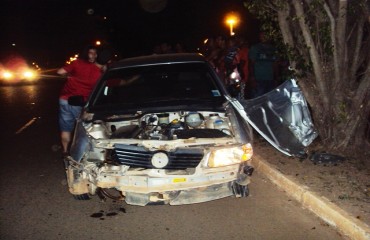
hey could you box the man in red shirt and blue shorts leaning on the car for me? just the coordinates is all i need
[57,46,102,156]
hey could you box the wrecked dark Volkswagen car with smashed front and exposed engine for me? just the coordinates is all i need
[66,54,315,206]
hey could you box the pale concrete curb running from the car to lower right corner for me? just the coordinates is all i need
[252,154,370,240]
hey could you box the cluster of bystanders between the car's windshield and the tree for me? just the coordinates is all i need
[201,33,279,99]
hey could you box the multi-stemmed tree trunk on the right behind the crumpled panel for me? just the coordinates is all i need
[246,0,370,158]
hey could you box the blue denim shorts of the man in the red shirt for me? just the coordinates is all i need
[59,99,82,132]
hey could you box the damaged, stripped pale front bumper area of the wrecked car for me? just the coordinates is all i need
[67,159,253,206]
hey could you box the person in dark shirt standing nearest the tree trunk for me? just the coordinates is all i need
[248,33,277,98]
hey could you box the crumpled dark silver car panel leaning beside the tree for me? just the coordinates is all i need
[229,80,317,158]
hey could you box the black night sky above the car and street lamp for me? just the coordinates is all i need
[0,0,257,67]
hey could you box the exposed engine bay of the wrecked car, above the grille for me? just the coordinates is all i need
[85,111,233,140]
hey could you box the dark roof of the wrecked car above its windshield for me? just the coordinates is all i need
[109,53,206,69]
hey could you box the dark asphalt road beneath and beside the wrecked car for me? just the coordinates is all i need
[0,79,344,240]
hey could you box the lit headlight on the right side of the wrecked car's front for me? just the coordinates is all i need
[208,143,253,167]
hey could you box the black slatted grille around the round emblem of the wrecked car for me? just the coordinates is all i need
[112,144,204,169]
